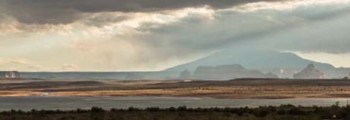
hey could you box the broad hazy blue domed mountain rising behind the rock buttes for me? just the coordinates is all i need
[165,48,350,78]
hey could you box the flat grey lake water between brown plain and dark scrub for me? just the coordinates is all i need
[0,97,348,111]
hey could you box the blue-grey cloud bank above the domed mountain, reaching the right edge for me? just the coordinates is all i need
[132,1,350,55]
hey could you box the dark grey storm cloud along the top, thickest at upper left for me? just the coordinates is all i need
[0,0,280,24]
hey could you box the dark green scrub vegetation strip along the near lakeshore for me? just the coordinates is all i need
[0,103,350,120]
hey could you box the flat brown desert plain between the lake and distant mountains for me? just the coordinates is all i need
[0,79,350,99]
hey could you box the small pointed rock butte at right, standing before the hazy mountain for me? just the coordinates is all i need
[293,64,325,79]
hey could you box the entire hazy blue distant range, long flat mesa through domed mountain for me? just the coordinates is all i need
[0,48,350,80]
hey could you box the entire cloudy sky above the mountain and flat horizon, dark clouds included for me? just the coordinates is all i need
[0,0,350,71]
